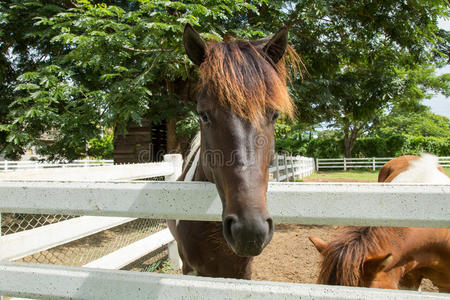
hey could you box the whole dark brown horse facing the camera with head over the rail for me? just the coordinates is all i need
[168,24,294,279]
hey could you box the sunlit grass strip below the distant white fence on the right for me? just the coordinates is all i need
[300,167,450,182]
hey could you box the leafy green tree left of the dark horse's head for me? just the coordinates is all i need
[1,0,280,159]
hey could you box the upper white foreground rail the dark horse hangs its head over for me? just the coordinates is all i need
[0,182,450,227]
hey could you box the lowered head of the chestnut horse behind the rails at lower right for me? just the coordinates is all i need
[309,227,400,289]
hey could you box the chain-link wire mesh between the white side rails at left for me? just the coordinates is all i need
[0,176,169,271]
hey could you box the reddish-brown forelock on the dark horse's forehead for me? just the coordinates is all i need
[199,41,298,123]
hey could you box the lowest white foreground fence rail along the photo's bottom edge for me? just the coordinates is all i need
[0,263,450,300]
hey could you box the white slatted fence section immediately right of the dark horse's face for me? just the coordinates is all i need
[269,154,315,181]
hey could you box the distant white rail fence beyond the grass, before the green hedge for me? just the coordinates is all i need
[316,156,450,171]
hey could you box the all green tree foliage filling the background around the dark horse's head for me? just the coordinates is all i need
[0,0,450,159]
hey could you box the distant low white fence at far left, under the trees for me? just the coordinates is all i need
[0,159,114,171]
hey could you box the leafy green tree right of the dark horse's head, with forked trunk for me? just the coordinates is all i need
[288,0,450,157]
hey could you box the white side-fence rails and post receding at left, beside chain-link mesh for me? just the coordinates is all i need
[0,154,182,269]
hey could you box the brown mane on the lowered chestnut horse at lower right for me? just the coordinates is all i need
[318,226,402,286]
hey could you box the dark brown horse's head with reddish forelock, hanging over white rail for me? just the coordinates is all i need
[184,24,294,256]
